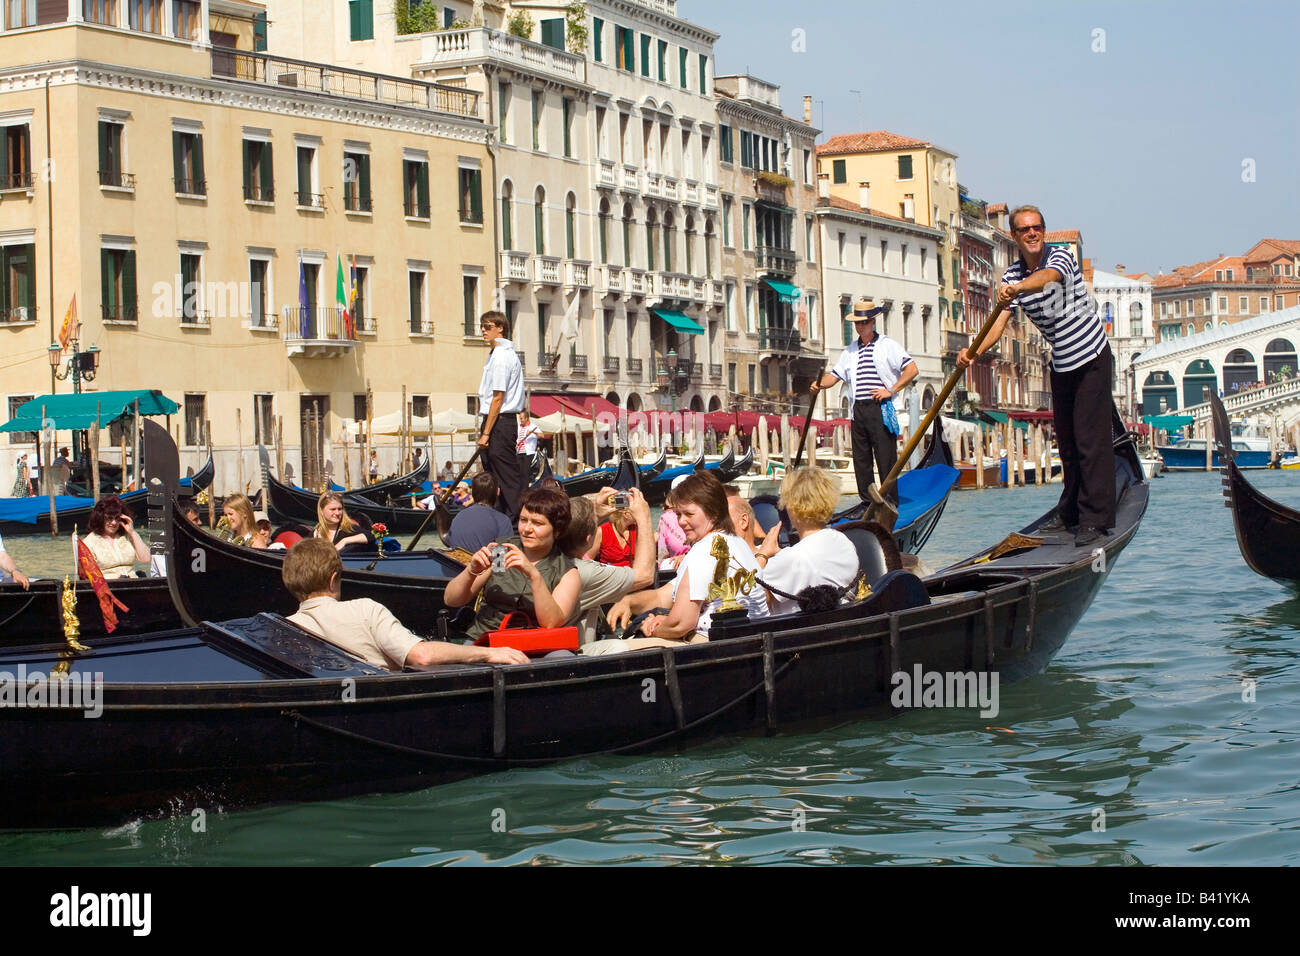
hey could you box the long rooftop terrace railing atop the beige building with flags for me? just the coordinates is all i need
[212,47,478,120]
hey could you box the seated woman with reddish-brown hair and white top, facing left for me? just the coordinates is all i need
[595,472,767,654]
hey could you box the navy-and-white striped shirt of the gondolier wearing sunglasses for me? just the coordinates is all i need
[1002,246,1106,372]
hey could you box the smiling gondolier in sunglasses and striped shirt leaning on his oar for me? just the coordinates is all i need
[957,206,1115,546]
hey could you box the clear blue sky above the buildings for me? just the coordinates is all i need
[702,0,1300,274]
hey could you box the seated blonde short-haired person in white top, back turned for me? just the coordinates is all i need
[758,467,858,614]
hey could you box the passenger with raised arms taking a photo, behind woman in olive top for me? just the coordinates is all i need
[564,488,654,644]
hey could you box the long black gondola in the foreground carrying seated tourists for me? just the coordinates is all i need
[0,408,1148,827]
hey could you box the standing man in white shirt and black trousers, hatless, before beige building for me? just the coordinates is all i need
[478,312,525,522]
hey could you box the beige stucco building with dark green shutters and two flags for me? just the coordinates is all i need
[0,0,497,493]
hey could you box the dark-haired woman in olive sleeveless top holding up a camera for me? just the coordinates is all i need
[443,488,582,639]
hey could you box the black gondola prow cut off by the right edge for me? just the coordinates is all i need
[1210,389,1300,584]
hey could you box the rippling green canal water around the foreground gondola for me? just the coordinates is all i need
[0,472,1300,866]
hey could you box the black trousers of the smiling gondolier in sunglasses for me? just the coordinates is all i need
[1052,345,1115,528]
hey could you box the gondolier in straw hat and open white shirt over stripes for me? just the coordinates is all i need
[811,299,918,501]
